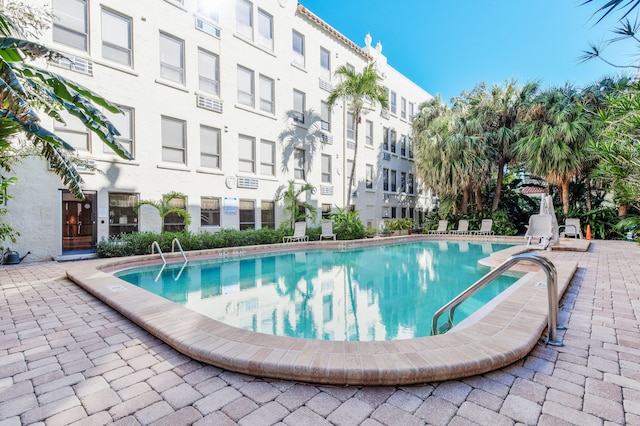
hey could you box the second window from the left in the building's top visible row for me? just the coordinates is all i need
[102,9,133,66]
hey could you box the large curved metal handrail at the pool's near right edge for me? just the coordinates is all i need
[431,253,565,346]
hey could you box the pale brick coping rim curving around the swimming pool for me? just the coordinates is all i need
[67,235,577,385]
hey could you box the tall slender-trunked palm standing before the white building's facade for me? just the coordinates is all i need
[327,63,389,207]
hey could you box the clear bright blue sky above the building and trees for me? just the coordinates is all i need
[300,0,637,102]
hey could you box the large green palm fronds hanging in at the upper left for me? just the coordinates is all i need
[0,9,132,199]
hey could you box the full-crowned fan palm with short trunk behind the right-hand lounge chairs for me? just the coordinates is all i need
[514,85,593,214]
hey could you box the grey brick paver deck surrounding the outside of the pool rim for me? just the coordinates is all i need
[0,241,640,426]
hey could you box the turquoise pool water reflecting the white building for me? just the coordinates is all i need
[116,241,517,341]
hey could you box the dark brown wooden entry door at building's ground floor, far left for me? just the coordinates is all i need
[62,191,96,252]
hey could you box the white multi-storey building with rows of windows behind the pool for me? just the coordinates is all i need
[7,0,431,260]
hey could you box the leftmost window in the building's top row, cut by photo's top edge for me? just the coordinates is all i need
[53,0,89,52]
